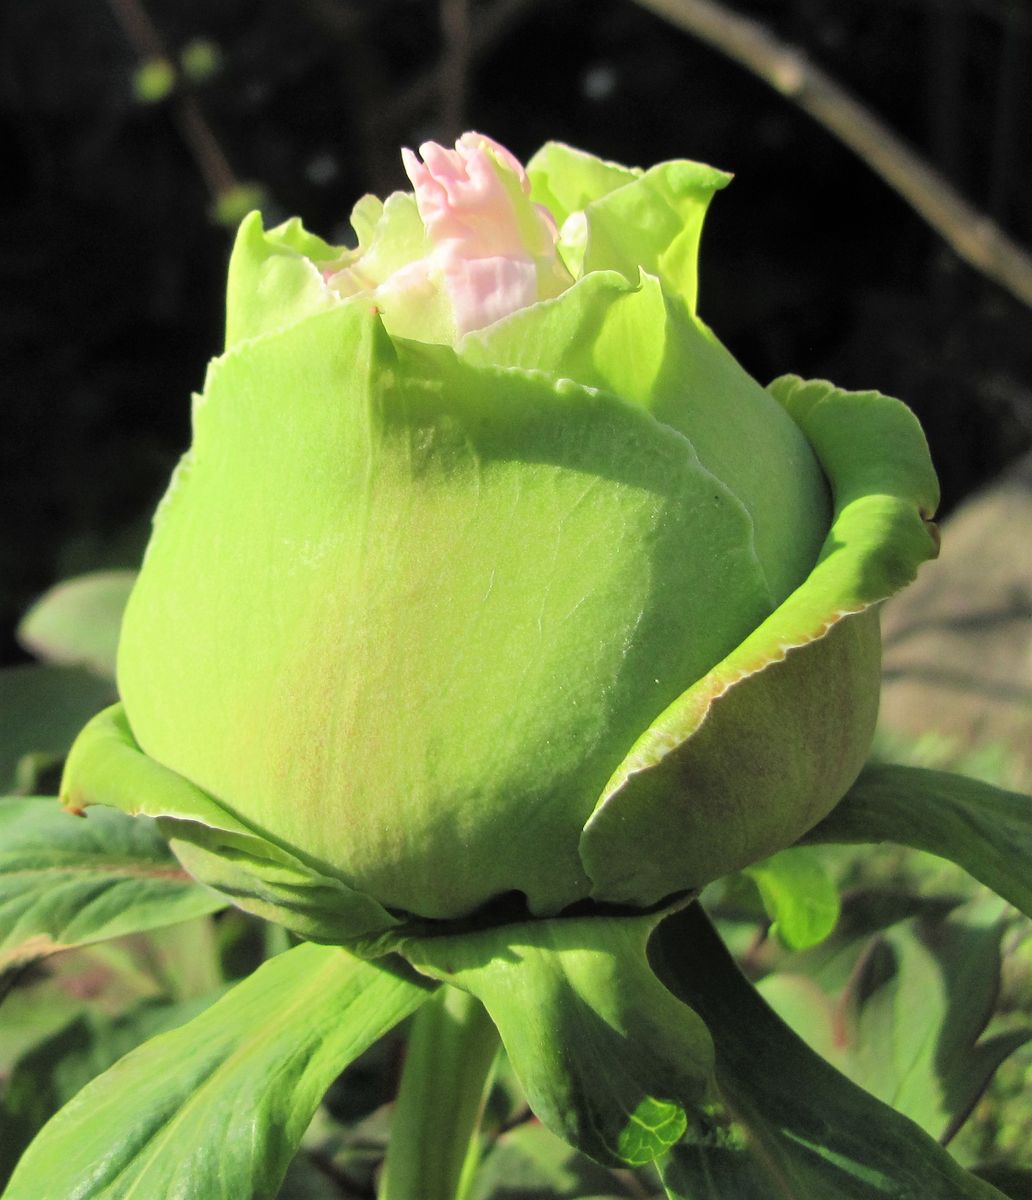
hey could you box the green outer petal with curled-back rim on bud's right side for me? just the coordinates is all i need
[581,377,937,904]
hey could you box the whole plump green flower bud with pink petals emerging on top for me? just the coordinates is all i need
[65,134,937,941]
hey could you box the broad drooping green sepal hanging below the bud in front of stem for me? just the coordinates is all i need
[396,908,713,1166]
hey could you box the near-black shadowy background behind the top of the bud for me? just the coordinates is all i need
[0,0,1032,661]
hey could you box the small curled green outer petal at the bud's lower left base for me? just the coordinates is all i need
[61,704,400,944]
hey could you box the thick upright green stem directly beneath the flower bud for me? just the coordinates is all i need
[379,986,498,1200]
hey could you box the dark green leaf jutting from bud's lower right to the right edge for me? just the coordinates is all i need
[805,766,1032,917]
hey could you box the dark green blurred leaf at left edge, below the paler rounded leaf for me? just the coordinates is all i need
[0,664,115,793]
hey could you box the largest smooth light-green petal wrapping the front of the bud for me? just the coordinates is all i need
[119,305,769,918]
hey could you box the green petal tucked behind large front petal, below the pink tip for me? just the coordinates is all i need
[460,271,830,608]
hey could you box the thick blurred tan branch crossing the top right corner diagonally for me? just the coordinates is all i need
[636,0,1032,306]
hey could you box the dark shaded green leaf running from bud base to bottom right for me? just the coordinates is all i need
[653,905,1000,1200]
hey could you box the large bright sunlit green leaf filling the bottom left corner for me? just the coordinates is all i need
[4,944,427,1200]
